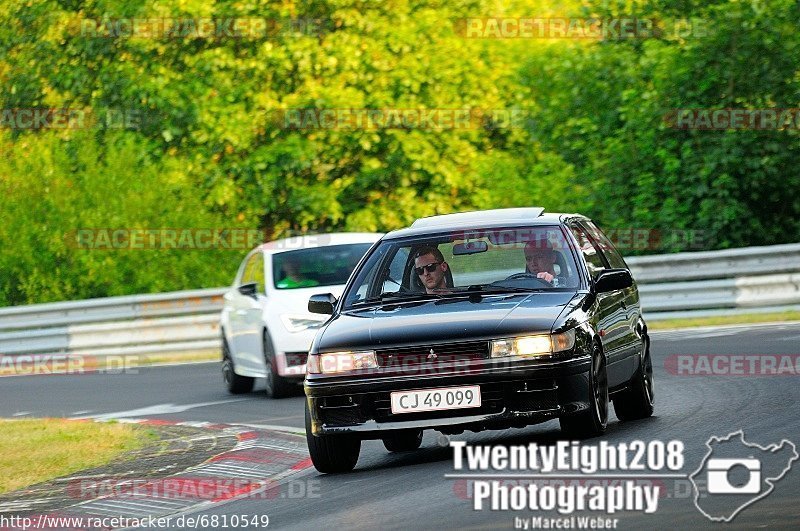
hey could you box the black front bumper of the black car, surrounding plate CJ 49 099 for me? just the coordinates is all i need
[304,355,591,439]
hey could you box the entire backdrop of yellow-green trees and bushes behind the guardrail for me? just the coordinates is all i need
[0,0,800,305]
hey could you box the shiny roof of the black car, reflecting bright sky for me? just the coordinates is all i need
[384,207,587,239]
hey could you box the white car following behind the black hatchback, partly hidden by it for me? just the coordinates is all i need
[220,233,381,398]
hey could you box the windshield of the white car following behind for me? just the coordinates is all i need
[272,243,372,289]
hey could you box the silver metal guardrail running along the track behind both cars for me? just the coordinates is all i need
[0,244,800,355]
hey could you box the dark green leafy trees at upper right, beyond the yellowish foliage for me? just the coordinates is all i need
[524,0,800,248]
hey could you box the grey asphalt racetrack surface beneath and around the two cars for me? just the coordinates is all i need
[0,324,800,529]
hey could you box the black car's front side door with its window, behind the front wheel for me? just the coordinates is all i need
[568,222,630,388]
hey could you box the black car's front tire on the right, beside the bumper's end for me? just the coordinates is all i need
[558,345,609,439]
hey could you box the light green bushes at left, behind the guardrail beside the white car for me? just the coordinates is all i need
[0,131,239,302]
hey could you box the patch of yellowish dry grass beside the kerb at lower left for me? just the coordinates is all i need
[0,419,155,494]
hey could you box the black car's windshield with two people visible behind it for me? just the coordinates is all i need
[344,226,580,308]
